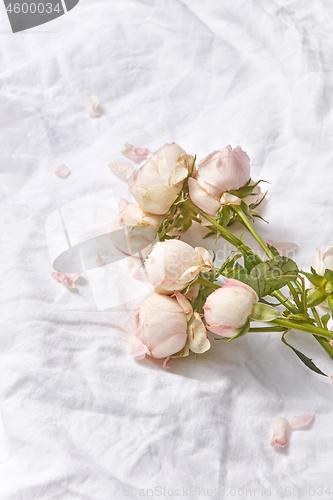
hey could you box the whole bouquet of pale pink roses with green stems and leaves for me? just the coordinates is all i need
[112,143,333,375]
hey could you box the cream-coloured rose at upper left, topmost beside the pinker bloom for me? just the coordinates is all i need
[128,142,194,215]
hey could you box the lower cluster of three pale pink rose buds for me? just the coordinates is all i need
[130,240,258,359]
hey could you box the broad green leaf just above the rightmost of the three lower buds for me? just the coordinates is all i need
[248,256,298,298]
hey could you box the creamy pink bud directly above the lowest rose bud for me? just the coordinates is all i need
[145,240,213,295]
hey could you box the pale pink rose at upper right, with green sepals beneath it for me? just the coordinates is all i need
[188,146,250,216]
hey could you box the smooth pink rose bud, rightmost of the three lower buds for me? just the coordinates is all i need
[204,279,258,337]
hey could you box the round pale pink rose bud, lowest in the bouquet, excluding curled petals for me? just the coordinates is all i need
[130,293,187,359]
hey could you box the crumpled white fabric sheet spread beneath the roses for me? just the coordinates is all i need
[0,0,333,500]
